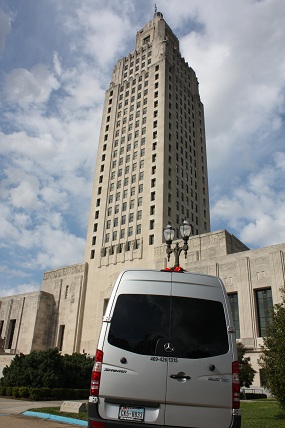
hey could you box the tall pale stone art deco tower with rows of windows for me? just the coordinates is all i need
[79,12,210,352]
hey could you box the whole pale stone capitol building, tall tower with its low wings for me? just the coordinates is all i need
[0,12,285,386]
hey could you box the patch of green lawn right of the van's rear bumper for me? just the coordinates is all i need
[241,400,285,428]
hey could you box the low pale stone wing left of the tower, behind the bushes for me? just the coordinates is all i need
[0,263,87,373]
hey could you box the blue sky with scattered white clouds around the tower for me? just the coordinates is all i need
[0,0,285,296]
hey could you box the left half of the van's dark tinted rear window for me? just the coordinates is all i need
[108,294,170,355]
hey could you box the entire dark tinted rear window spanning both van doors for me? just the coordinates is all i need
[108,294,229,359]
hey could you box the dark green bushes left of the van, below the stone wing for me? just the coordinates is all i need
[0,348,93,392]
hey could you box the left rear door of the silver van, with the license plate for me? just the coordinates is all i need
[98,271,171,425]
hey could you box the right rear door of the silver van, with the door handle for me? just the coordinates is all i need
[165,273,233,428]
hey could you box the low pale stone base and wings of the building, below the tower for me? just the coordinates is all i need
[0,230,285,386]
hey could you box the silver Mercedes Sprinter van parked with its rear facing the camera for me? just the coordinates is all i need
[88,270,241,428]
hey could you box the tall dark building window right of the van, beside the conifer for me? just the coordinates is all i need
[255,288,273,337]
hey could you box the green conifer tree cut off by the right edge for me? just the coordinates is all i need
[258,290,285,410]
